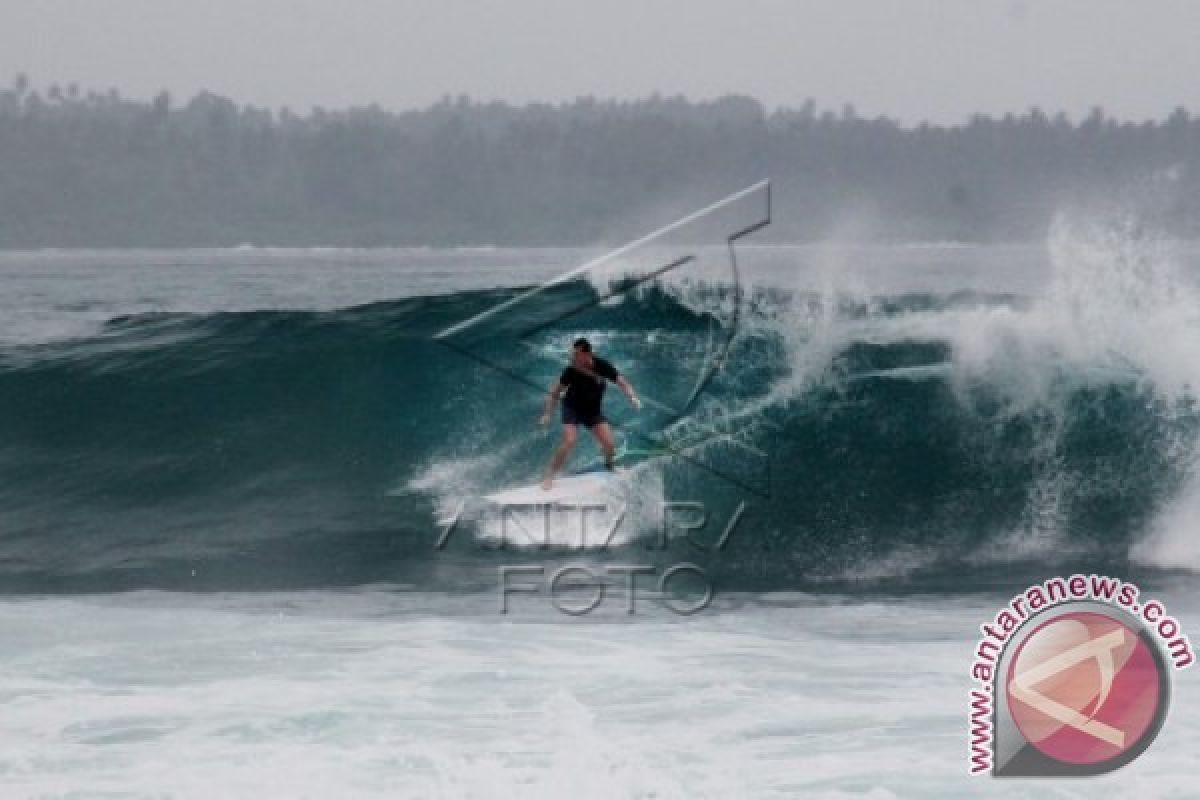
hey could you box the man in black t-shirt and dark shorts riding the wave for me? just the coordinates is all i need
[541,339,642,489]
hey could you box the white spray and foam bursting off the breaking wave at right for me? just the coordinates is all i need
[715,215,1200,570]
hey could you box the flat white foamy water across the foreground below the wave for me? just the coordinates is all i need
[0,590,1200,800]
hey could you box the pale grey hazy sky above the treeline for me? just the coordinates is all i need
[0,0,1200,122]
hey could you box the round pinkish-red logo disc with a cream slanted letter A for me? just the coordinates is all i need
[1006,612,1166,765]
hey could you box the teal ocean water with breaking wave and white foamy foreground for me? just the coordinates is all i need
[0,221,1200,798]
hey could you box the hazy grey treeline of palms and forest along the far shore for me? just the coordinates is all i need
[0,76,1200,248]
